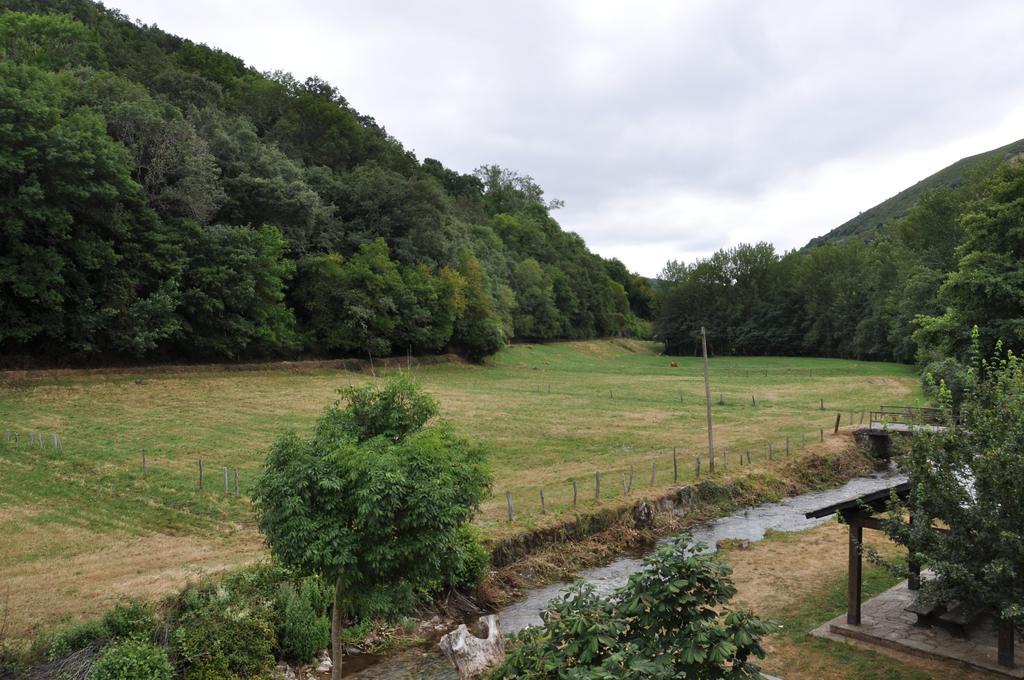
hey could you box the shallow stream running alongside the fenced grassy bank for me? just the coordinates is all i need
[345,471,906,680]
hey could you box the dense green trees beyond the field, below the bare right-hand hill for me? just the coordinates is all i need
[655,150,1024,364]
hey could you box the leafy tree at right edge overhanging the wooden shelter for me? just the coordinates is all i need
[886,346,1024,629]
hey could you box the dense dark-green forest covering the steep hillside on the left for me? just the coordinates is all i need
[0,0,653,366]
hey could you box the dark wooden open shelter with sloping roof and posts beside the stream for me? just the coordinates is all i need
[805,481,1014,668]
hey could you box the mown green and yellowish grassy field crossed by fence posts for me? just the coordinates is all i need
[0,341,923,634]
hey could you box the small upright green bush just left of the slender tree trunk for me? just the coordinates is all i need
[276,578,331,663]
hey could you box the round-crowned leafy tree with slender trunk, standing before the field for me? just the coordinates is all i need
[254,377,489,678]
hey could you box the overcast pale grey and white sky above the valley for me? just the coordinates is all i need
[108,0,1024,274]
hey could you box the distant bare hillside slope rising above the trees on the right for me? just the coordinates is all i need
[807,139,1024,248]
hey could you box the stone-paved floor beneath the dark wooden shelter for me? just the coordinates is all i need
[811,581,1024,678]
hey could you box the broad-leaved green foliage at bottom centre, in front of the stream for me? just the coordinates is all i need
[490,538,770,680]
